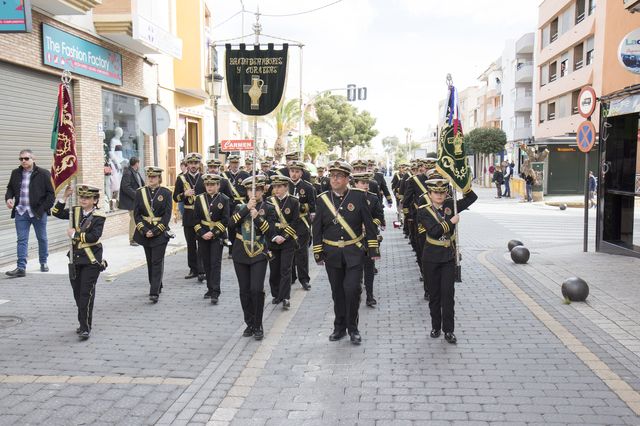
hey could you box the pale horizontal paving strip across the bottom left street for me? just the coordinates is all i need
[0,374,193,386]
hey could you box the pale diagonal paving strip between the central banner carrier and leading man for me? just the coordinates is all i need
[207,268,322,426]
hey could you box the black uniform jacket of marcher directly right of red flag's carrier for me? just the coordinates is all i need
[133,186,173,247]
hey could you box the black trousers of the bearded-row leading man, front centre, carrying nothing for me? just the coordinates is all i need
[325,264,362,332]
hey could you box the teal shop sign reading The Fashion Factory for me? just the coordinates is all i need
[42,24,122,86]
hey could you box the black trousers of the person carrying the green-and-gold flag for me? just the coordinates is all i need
[424,260,456,333]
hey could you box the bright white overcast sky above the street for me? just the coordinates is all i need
[209,0,541,151]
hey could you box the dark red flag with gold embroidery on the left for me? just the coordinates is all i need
[51,84,78,192]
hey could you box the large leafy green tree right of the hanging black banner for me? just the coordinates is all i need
[309,94,378,157]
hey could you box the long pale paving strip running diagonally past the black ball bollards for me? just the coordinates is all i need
[477,251,640,415]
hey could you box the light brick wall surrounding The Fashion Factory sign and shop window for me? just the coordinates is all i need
[0,11,152,238]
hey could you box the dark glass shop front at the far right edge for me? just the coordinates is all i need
[596,86,640,257]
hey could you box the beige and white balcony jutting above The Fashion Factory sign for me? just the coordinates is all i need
[93,0,182,59]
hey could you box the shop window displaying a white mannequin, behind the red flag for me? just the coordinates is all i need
[102,90,144,211]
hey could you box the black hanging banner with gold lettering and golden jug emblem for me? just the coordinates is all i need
[225,43,289,116]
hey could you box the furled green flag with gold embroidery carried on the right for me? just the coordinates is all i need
[436,85,471,193]
